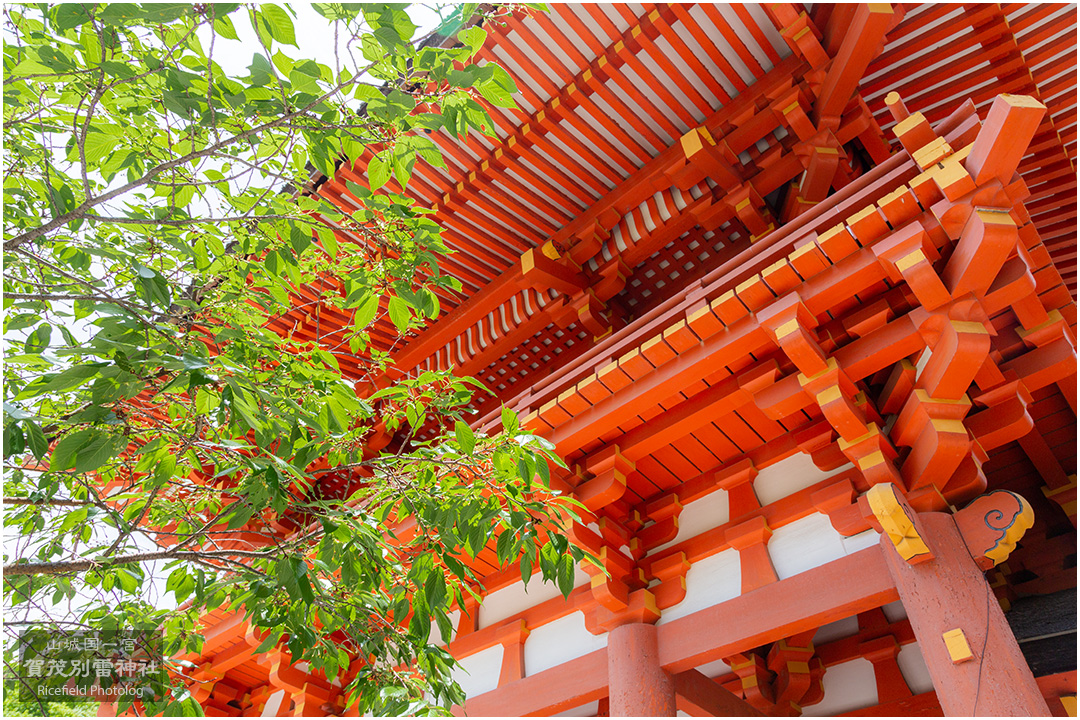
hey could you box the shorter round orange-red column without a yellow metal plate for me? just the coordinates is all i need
[608,623,675,718]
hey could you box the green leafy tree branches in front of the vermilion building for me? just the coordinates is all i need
[3,3,582,715]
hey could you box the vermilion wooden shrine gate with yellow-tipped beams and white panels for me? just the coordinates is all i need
[103,3,1077,716]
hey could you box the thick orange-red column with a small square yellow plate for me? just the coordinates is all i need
[881,513,1050,717]
